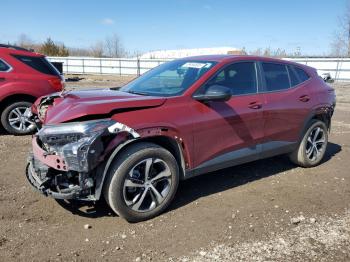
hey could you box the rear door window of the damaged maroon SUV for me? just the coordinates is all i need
[262,63,290,91]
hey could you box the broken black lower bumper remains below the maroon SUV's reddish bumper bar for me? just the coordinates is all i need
[26,155,95,201]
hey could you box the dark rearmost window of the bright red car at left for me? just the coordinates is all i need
[13,55,59,76]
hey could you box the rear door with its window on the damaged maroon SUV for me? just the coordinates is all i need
[260,62,311,151]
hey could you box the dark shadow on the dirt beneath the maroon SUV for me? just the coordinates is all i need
[57,142,342,218]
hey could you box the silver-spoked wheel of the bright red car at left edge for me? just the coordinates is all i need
[1,101,35,135]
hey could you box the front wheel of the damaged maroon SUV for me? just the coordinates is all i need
[104,143,179,222]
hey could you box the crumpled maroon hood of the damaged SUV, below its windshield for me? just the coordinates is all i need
[37,89,166,124]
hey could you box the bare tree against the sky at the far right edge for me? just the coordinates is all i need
[331,0,350,57]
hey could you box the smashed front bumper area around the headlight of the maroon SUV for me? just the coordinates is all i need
[26,122,140,201]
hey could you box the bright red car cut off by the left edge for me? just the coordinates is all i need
[0,44,63,135]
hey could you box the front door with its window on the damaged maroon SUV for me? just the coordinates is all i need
[193,61,264,172]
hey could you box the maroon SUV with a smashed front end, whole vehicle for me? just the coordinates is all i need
[26,56,335,222]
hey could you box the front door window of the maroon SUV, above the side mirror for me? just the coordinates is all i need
[208,62,257,95]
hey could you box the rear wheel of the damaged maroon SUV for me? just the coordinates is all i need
[289,119,328,167]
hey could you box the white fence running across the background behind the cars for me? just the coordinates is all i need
[48,57,350,81]
